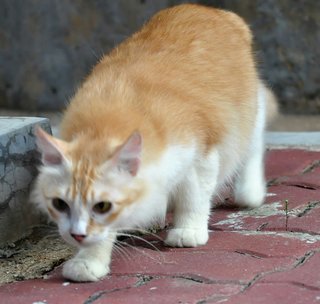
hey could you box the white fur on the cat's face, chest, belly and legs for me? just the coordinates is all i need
[34,85,266,281]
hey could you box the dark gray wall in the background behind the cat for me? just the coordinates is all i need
[0,0,320,113]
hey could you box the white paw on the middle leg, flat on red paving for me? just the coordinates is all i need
[165,228,209,247]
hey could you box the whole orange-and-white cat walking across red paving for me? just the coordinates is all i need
[33,4,276,281]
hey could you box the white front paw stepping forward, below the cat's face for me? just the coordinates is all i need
[62,258,109,282]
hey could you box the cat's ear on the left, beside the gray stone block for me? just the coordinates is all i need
[35,127,66,166]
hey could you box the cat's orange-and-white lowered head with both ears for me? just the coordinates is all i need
[33,128,145,246]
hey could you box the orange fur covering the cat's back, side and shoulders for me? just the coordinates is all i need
[61,5,257,163]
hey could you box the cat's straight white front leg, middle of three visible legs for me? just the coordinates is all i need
[165,152,219,247]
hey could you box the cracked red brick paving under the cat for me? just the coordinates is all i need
[0,150,320,304]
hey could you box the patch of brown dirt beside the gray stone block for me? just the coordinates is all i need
[0,226,75,285]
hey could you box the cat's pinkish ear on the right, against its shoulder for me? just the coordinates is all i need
[112,131,142,176]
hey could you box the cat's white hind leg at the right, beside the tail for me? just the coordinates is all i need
[234,85,266,208]
